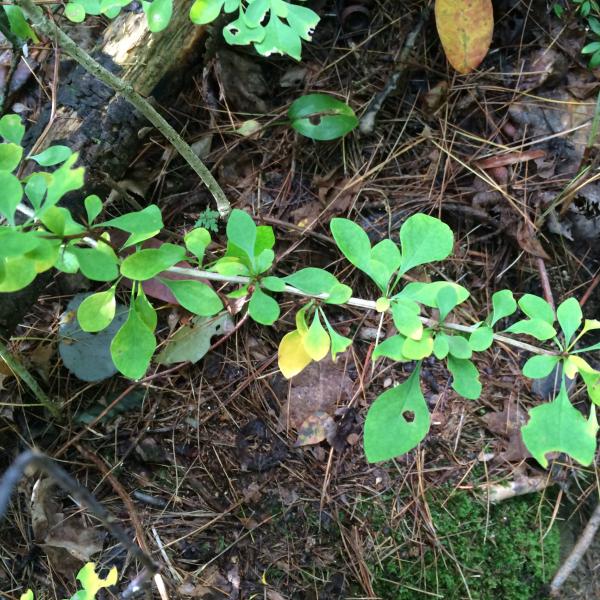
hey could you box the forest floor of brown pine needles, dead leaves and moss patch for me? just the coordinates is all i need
[0,0,600,600]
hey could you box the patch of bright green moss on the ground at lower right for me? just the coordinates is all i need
[366,488,560,600]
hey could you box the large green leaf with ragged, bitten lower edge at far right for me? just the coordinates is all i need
[521,381,598,468]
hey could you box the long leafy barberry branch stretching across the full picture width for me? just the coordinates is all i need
[0,115,600,466]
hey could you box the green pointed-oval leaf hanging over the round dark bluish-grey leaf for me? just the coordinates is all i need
[110,306,156,379]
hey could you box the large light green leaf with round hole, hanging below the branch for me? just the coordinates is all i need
[364,364,431,462]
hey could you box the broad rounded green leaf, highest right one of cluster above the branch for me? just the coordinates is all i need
[400,214,454,273]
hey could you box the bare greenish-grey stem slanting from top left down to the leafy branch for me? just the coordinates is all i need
[16,0,231,217]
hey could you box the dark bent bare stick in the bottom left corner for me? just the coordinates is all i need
[0,450,158,598]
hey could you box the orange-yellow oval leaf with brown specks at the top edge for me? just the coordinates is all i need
[435,0,494,74]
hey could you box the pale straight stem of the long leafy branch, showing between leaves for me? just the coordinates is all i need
[167,267,554,354]
